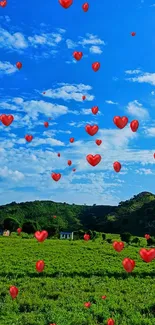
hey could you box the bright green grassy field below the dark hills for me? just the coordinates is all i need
[0,235,155,325]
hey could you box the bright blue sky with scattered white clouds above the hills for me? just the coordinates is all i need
[0,0,155,205]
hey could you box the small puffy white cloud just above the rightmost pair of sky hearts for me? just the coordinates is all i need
[127,100,149,119]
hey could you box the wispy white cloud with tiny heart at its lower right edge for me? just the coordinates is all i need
[44,83,94,102]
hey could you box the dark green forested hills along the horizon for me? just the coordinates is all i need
[0,192,155,236]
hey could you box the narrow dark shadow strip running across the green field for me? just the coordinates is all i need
[0,271,155,279]
